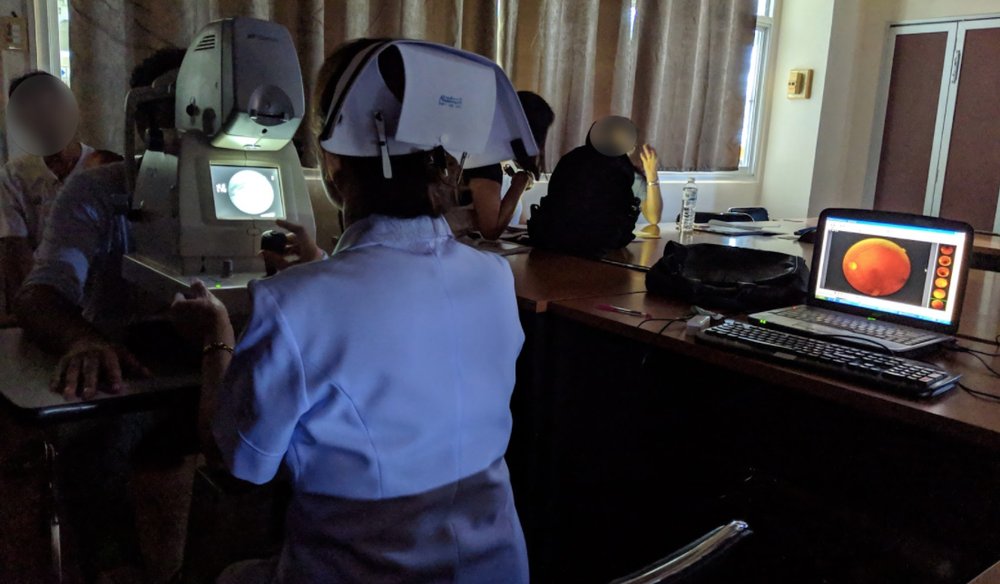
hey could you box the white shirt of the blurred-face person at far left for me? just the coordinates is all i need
[0,144,94,249]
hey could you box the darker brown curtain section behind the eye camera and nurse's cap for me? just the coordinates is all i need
[70,0,504,164]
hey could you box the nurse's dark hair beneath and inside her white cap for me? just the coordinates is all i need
[310,39,459,218]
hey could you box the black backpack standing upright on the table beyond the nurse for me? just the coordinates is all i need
[528,145,640,256]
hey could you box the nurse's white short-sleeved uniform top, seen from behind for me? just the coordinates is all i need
[213,216,524,500]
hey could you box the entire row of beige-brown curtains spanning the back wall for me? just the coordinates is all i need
[70,0,756,170]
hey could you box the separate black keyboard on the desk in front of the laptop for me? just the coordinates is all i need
[697,320,961,397]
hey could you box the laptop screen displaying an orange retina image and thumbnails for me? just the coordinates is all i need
[812,215,968,326]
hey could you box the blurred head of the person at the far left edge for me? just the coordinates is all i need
[7,71,80,157]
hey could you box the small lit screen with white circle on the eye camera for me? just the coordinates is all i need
[210,164,285,220]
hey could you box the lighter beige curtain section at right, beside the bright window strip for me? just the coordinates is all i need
[509,0,756,171]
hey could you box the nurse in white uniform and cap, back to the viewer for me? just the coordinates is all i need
[174,40,534,584]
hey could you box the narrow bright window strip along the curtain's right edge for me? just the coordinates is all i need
[738,0,775,174]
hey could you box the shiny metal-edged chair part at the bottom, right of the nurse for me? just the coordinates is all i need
[611,520,753,584]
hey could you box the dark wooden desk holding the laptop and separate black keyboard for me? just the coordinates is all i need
[535,293,1000,584]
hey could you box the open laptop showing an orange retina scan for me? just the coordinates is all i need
[749,209,973,354]
